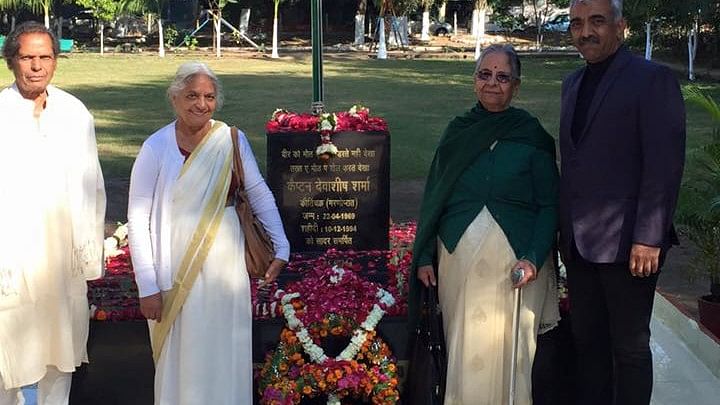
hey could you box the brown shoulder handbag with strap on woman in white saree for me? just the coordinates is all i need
[230,127,275,278]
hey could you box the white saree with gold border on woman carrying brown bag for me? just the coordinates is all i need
[150,122,252,405]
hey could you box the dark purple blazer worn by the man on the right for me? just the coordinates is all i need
[559,47,685,263]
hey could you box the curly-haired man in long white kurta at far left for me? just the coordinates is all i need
[0,23,105,405]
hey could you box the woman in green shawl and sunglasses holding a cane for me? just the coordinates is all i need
[409,45,559,405]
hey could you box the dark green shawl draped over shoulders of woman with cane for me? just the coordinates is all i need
[408,103,555,328]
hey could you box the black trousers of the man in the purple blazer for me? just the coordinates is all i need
[565,244,662,405]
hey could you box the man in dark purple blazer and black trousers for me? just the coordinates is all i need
[560,0,685,405]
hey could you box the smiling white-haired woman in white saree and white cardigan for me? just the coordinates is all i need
[128,62,290,405]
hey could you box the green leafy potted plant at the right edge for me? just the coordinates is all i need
[677,86,720,337]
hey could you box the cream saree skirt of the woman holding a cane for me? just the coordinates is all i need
[438,208,560,405]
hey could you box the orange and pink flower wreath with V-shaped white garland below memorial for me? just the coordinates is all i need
[259,267,399,405]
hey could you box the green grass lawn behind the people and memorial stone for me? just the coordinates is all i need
[0,54,720,179]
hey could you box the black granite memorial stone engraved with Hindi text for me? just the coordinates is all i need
[267,132,390,252]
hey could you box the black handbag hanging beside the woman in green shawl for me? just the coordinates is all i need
[402,287,447,405]
